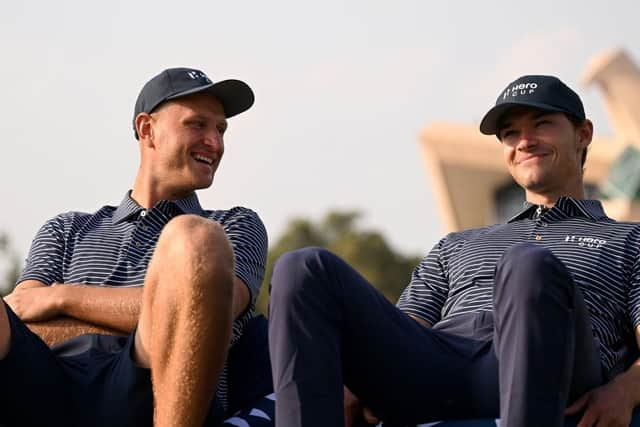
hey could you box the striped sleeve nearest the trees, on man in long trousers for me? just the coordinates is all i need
[398,238,449,325]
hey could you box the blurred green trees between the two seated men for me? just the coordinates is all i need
[257,211,420,313]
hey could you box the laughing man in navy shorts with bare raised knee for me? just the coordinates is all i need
[0,68,270,427]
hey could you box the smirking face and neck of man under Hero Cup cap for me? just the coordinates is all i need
[497,107,593,204]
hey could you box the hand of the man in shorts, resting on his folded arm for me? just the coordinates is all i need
[4,281,60,322]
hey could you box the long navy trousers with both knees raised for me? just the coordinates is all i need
[269,244,602,427]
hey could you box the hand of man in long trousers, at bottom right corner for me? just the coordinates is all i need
[565,378,634,427]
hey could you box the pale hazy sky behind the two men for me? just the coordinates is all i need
[0,0,640,268]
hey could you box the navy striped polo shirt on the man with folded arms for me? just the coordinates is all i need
[18,191,267,407]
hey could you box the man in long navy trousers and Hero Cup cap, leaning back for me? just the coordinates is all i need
[269,76,640,427]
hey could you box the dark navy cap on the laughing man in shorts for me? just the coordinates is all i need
[133,68,255,139]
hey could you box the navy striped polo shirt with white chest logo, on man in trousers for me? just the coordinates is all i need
[398,197,640,377]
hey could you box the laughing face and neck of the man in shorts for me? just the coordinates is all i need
[141,92,227,199]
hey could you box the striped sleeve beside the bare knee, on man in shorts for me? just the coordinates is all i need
[222,208,268,301]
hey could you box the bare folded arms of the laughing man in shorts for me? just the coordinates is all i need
[5,277,250,346]
